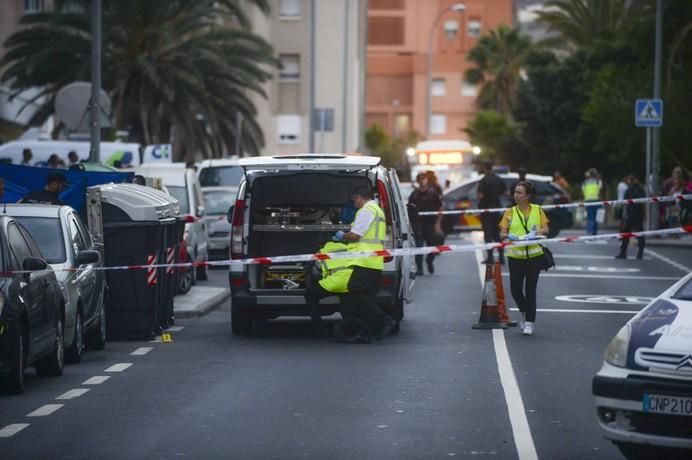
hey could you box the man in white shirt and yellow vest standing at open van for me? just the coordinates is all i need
[334,187,395,343]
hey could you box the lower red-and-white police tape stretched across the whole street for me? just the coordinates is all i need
[0,225,692,275]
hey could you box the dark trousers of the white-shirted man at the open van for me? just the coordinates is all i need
[348,266,391,336]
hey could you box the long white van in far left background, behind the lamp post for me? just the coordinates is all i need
[0,140,142,168]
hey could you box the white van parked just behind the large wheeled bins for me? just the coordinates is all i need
[135,163,209,283]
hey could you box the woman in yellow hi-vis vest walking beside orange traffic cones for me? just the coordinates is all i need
[500,181,549,335]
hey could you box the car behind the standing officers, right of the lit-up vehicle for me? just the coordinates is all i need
[442,172,574,238]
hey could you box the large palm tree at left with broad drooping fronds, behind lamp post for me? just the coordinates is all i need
[0,0,278,158]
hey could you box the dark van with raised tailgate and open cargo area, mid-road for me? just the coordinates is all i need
[229,155,415,334]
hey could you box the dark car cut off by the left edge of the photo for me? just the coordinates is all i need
[0,216,65,393]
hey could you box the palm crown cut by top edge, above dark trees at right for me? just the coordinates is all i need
[538,0,655,52]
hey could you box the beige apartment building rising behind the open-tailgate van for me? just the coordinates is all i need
[253,0,367,155]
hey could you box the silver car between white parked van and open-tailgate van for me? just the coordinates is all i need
[202,187,238,260]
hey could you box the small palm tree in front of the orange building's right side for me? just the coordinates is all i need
[464,26,531,113]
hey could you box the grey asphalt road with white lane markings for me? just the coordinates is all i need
[0,235,692,459]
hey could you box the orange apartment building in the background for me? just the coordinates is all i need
[366,0,514,140]
